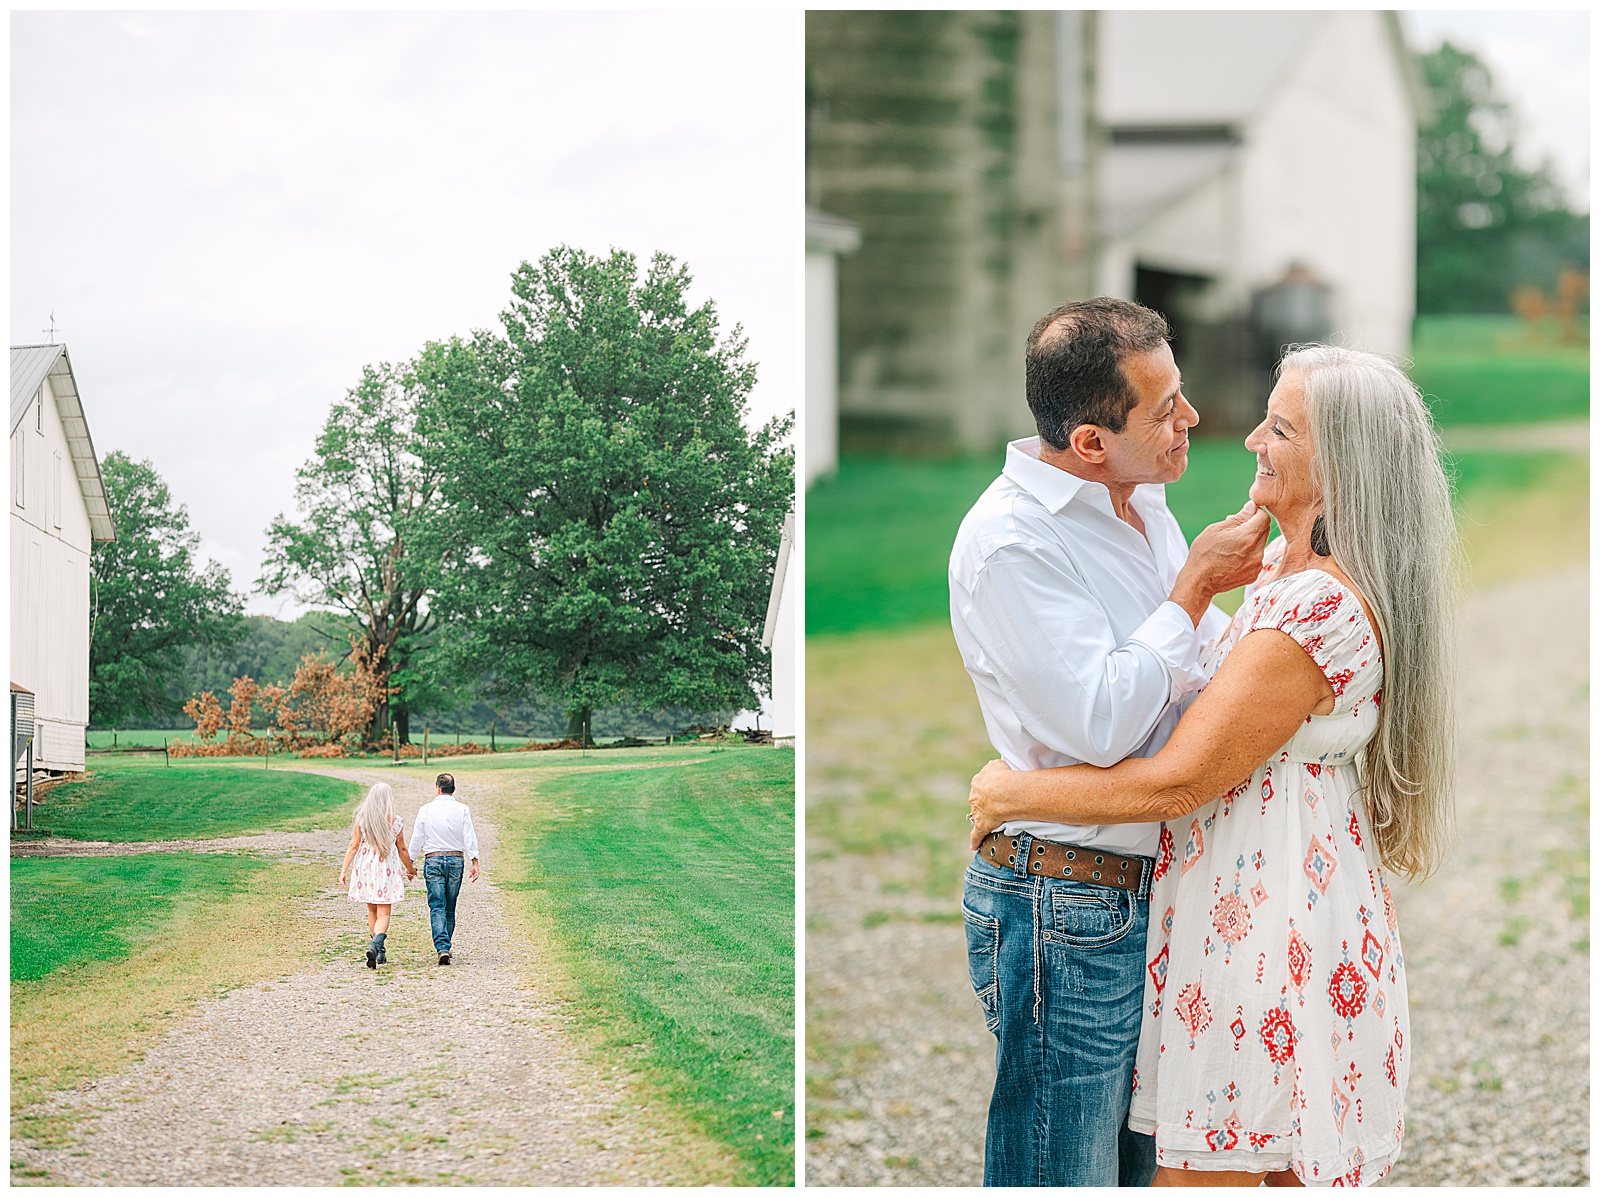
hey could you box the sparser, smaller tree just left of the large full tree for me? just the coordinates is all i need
[256,363,437,741]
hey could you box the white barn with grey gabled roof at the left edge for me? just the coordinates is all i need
[11,346,117,771]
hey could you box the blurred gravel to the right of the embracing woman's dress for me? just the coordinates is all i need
[1390,570,1590,1184]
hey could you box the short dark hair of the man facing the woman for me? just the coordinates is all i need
[1027,296,1171,448]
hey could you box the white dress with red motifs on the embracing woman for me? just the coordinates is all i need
[1128,539,1410,1184]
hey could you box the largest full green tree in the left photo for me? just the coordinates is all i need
[418,246,794,735]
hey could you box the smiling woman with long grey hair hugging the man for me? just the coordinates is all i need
[973,346,1454,1184]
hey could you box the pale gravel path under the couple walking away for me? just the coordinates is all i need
[11,771,723,1186]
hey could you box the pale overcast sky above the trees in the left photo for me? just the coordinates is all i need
[11,11,803,615]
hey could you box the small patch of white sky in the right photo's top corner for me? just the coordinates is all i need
[1405,10,1589,211]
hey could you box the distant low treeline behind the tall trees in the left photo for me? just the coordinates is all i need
[106,611,736,739]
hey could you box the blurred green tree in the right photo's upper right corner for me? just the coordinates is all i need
[1416,42,1589,312]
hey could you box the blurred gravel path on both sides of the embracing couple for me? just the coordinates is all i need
[805,568,1590,1186]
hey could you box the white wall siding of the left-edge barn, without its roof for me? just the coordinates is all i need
[11,369,90,770]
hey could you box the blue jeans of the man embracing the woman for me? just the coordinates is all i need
[962,835,1155,1186]
